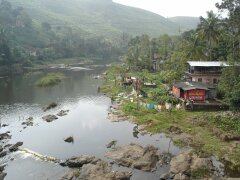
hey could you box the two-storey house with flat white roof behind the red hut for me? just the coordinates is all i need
[185,61,229,85]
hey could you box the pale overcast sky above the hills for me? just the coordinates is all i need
[113,0,221,17]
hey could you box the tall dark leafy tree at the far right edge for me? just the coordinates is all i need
[216,0,240,110]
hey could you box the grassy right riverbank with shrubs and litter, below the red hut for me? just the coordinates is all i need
[101,65,240,174]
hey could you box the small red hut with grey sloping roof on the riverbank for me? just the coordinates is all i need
[172,82,210,101]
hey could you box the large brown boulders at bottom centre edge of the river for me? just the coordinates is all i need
[60,141,161,180]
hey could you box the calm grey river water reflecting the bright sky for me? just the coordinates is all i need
[0,69,188,180]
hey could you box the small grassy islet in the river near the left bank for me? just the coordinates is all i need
[36,73,66,87]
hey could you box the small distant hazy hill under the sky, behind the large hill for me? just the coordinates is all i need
[168,16,200,32]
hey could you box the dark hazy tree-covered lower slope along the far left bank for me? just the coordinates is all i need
[0,0,128,66]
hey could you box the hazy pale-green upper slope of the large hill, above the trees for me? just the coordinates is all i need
[9,0,196,36]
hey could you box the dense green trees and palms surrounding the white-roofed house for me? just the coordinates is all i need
[125,0,240,109]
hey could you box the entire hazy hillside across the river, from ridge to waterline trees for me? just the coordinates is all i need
[0,0,199,66]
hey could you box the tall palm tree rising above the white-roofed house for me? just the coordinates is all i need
[197,11,221,60]
